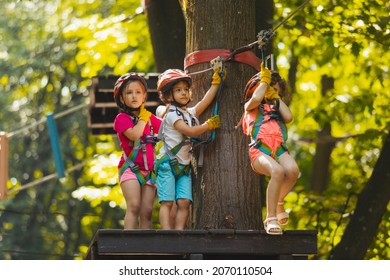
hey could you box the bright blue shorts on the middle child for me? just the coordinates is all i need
[156,161,192,203]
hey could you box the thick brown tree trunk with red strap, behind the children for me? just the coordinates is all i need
[183,0,272,229]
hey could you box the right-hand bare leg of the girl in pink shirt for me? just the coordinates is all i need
[139,185,156,229]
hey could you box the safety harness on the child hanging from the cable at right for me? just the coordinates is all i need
[249,103,288,158]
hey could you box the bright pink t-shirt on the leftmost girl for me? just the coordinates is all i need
[114,113,162,171]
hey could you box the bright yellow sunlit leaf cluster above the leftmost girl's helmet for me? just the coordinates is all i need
[64,3,153,77]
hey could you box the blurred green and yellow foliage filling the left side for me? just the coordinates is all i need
[0,0,153,259]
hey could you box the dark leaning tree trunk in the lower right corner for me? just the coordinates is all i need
[330,135,390,260]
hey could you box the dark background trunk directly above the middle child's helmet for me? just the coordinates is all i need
[145,0,186,72]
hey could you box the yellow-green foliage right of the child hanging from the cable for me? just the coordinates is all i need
[274,0,390,259]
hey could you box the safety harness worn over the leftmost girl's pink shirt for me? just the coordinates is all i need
[119,116,158,186]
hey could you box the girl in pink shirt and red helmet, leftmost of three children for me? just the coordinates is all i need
[114,73,161,229]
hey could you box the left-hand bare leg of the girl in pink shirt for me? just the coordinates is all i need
[121,180,141,229]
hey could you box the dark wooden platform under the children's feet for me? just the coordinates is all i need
[85,229,317,260]
